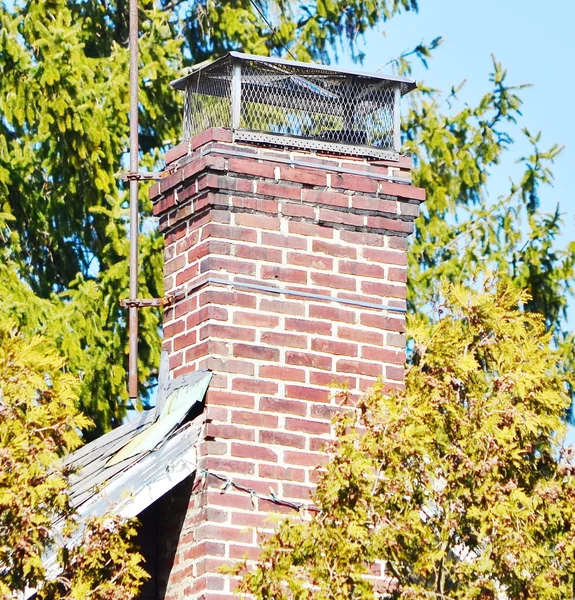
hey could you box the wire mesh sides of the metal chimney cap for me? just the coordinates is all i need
[184,58,400,158]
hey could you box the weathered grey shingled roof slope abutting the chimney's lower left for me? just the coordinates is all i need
[65,371,211,518]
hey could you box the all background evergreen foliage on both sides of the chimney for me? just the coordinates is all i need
[0,0,575,435]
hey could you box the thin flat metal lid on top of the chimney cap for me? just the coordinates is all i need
[171,52,417,94]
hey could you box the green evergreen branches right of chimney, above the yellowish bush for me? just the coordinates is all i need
[404,57,575,376]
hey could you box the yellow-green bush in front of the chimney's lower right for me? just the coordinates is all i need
[232,283,575,600]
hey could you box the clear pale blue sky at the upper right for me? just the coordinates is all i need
[340,0,575,262]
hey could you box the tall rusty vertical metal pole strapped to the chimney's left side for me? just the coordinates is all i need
[128,0,140,400]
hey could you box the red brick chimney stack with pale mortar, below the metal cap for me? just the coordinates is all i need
[152,130,424,600]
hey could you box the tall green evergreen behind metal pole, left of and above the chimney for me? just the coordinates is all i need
[0,0,416,435]
